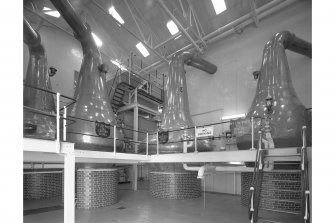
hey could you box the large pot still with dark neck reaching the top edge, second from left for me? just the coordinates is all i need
[51,0,124,152]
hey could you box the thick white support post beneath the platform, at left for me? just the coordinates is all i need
[64,151,75,223]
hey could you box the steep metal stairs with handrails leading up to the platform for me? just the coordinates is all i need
[248,126,310,223]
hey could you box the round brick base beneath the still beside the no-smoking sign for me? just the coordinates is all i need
[149,172,201,199]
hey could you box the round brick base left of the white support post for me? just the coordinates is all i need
[23,171,63,200]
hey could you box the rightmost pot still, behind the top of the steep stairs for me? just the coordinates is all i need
[236,31,312,150]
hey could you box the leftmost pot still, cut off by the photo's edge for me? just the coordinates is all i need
[23,18,56,140]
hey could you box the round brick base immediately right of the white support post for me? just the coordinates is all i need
[76,169,119,209]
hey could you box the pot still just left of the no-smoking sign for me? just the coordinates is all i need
[139,51,217,154]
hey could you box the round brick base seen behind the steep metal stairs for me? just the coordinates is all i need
[241,172,301,212]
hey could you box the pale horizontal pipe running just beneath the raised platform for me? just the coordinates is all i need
[183,163,254,179]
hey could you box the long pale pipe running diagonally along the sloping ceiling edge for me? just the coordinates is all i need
[140,0,297,72]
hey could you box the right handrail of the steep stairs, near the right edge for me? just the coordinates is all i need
[301,126,310,223]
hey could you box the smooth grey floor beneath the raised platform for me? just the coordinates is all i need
[24,181,302,223]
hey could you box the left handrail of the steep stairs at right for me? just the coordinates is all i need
[248,131,265,223]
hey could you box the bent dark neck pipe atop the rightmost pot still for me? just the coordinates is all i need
[272,31,312,58]
